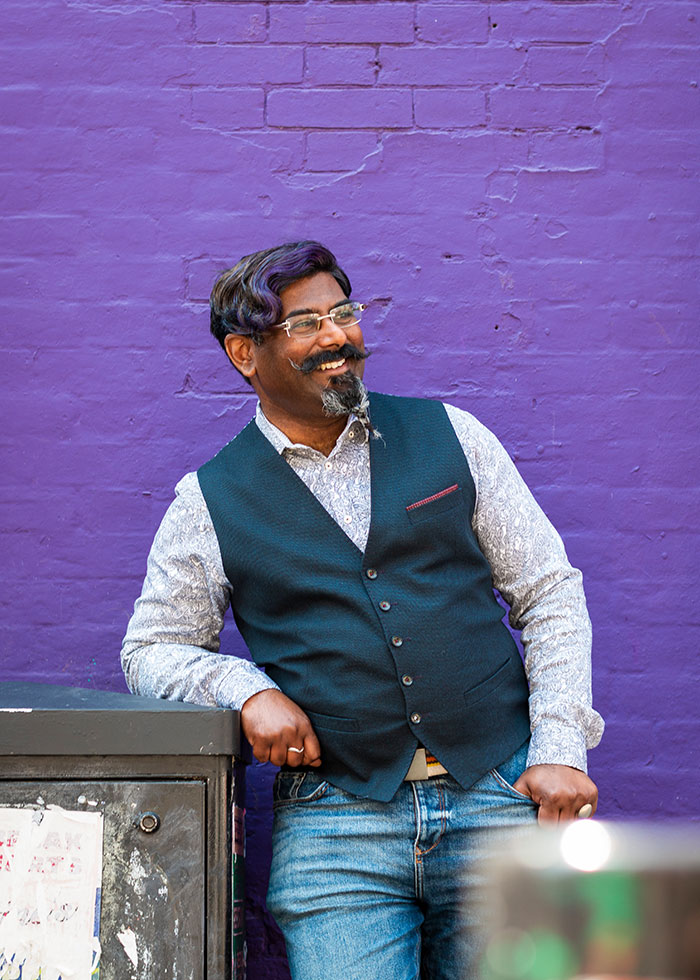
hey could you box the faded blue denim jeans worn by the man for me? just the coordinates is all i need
[267,743,537,980]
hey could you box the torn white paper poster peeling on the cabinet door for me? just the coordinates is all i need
[0,806,103,980]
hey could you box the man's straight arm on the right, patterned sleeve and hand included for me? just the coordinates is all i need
[446,406,603,820]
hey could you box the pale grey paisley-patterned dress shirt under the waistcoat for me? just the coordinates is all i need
[122,405,603,772]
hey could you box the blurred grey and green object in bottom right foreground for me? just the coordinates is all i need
[480,820,700,980]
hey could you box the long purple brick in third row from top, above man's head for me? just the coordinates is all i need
[267,88,412,129]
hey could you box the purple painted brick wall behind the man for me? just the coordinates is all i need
[0,0,700,980]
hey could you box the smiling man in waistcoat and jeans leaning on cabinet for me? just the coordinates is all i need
[123,242,602,980]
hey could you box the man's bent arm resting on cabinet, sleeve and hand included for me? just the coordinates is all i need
[122,473,320,765]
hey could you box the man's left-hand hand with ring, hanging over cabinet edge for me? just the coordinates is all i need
[241,688,321,766]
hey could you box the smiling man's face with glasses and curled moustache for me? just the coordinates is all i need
[232,272,365,430]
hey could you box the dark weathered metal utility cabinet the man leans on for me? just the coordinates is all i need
[0,683,244,980]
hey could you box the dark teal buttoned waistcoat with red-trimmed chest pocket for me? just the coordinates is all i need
[198,394,530,800]
